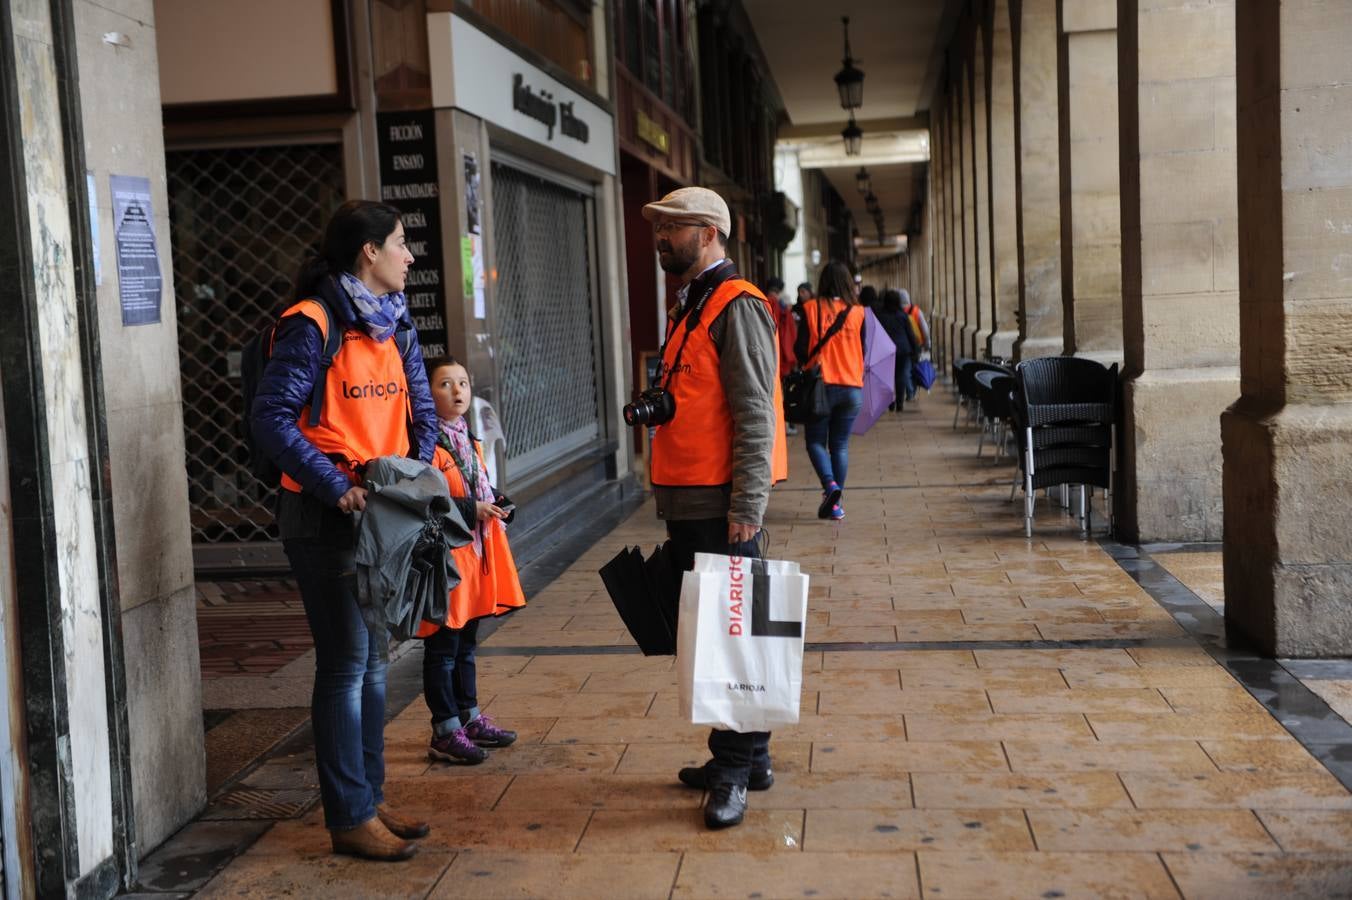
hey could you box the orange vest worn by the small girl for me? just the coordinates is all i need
[418,441,526,629]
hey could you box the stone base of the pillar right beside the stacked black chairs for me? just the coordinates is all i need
[1117,368,1240,543]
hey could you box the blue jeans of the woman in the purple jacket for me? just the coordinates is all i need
[283,536,387,828]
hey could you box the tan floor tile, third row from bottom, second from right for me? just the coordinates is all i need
[911,772,1132,809]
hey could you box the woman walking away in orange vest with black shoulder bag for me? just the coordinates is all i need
[794,261,864,522]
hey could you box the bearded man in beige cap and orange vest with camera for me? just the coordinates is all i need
[644,188,788,828]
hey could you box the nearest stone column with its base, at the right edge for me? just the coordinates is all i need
[1221,0,1352,657]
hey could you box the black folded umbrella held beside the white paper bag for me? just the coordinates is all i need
[600,545,681,657]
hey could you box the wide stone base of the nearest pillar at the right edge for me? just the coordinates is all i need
[1221,403,1352,657]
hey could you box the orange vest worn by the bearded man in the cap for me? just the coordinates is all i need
[652,278,788,488]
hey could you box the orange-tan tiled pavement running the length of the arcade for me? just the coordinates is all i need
[139,392,1352,900]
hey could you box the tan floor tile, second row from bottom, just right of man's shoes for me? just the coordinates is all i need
[803,809,1033,853]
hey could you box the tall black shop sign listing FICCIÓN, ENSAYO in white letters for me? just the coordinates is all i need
[376,109,446,357]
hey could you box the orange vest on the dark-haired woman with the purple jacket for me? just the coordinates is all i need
[281,300,412,493]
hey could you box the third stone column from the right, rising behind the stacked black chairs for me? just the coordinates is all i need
[1061,0,1122,364]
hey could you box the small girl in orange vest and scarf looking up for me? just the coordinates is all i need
[418,357,526,765]
